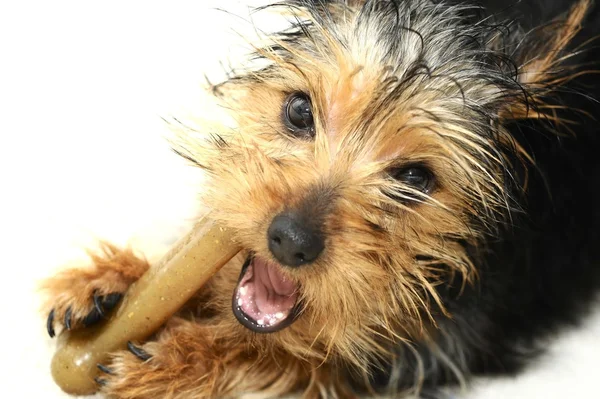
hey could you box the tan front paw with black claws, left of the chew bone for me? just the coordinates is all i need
[42,243,149,337]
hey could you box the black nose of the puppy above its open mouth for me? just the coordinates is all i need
[267,212,325,267]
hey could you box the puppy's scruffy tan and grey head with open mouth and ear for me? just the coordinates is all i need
[170,0,588,364]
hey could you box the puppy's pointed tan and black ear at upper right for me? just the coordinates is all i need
[501,0,591,119]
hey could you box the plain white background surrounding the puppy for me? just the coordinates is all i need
[0,0,600,399]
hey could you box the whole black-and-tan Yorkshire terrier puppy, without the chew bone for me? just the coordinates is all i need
[46,0,600,399]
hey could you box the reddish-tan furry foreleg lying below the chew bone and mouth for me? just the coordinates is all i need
[97,317,354,399]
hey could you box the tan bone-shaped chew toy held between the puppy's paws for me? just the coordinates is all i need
[51,218,239,395]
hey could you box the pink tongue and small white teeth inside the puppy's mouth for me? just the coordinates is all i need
[237,257,298,327]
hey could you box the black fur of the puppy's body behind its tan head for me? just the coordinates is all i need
[357,0,600,397]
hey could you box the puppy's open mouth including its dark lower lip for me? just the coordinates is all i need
[232,255,299,333]
